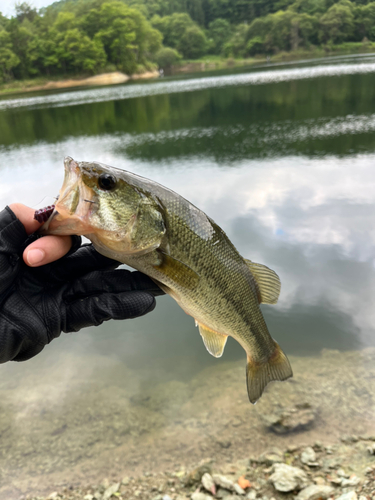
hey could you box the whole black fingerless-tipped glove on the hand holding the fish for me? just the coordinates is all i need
[0,207,164,363]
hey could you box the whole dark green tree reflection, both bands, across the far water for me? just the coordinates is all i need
[0,69,375,157]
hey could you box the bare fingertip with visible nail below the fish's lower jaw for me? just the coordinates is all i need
[23,236,72,267]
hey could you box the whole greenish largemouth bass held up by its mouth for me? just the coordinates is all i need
[42,157,292,403]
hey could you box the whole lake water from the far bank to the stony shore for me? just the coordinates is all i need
[0,55,375,499]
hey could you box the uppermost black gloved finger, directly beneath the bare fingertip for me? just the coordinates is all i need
[48,244,121,281]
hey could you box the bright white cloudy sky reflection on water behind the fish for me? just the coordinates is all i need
[0,136,375,350]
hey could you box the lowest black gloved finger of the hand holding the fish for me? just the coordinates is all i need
[63,291,156,333]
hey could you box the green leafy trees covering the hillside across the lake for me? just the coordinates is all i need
[0,0,375,81]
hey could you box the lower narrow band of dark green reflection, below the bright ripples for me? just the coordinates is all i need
[119,114,375,164]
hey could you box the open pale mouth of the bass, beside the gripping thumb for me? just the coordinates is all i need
[39,156,99,235]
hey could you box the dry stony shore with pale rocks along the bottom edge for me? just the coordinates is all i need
[25,435,375,500]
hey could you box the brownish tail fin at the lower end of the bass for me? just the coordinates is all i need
[246,342,293,404]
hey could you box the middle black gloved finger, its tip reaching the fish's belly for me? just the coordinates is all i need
[64,269,164,302]
